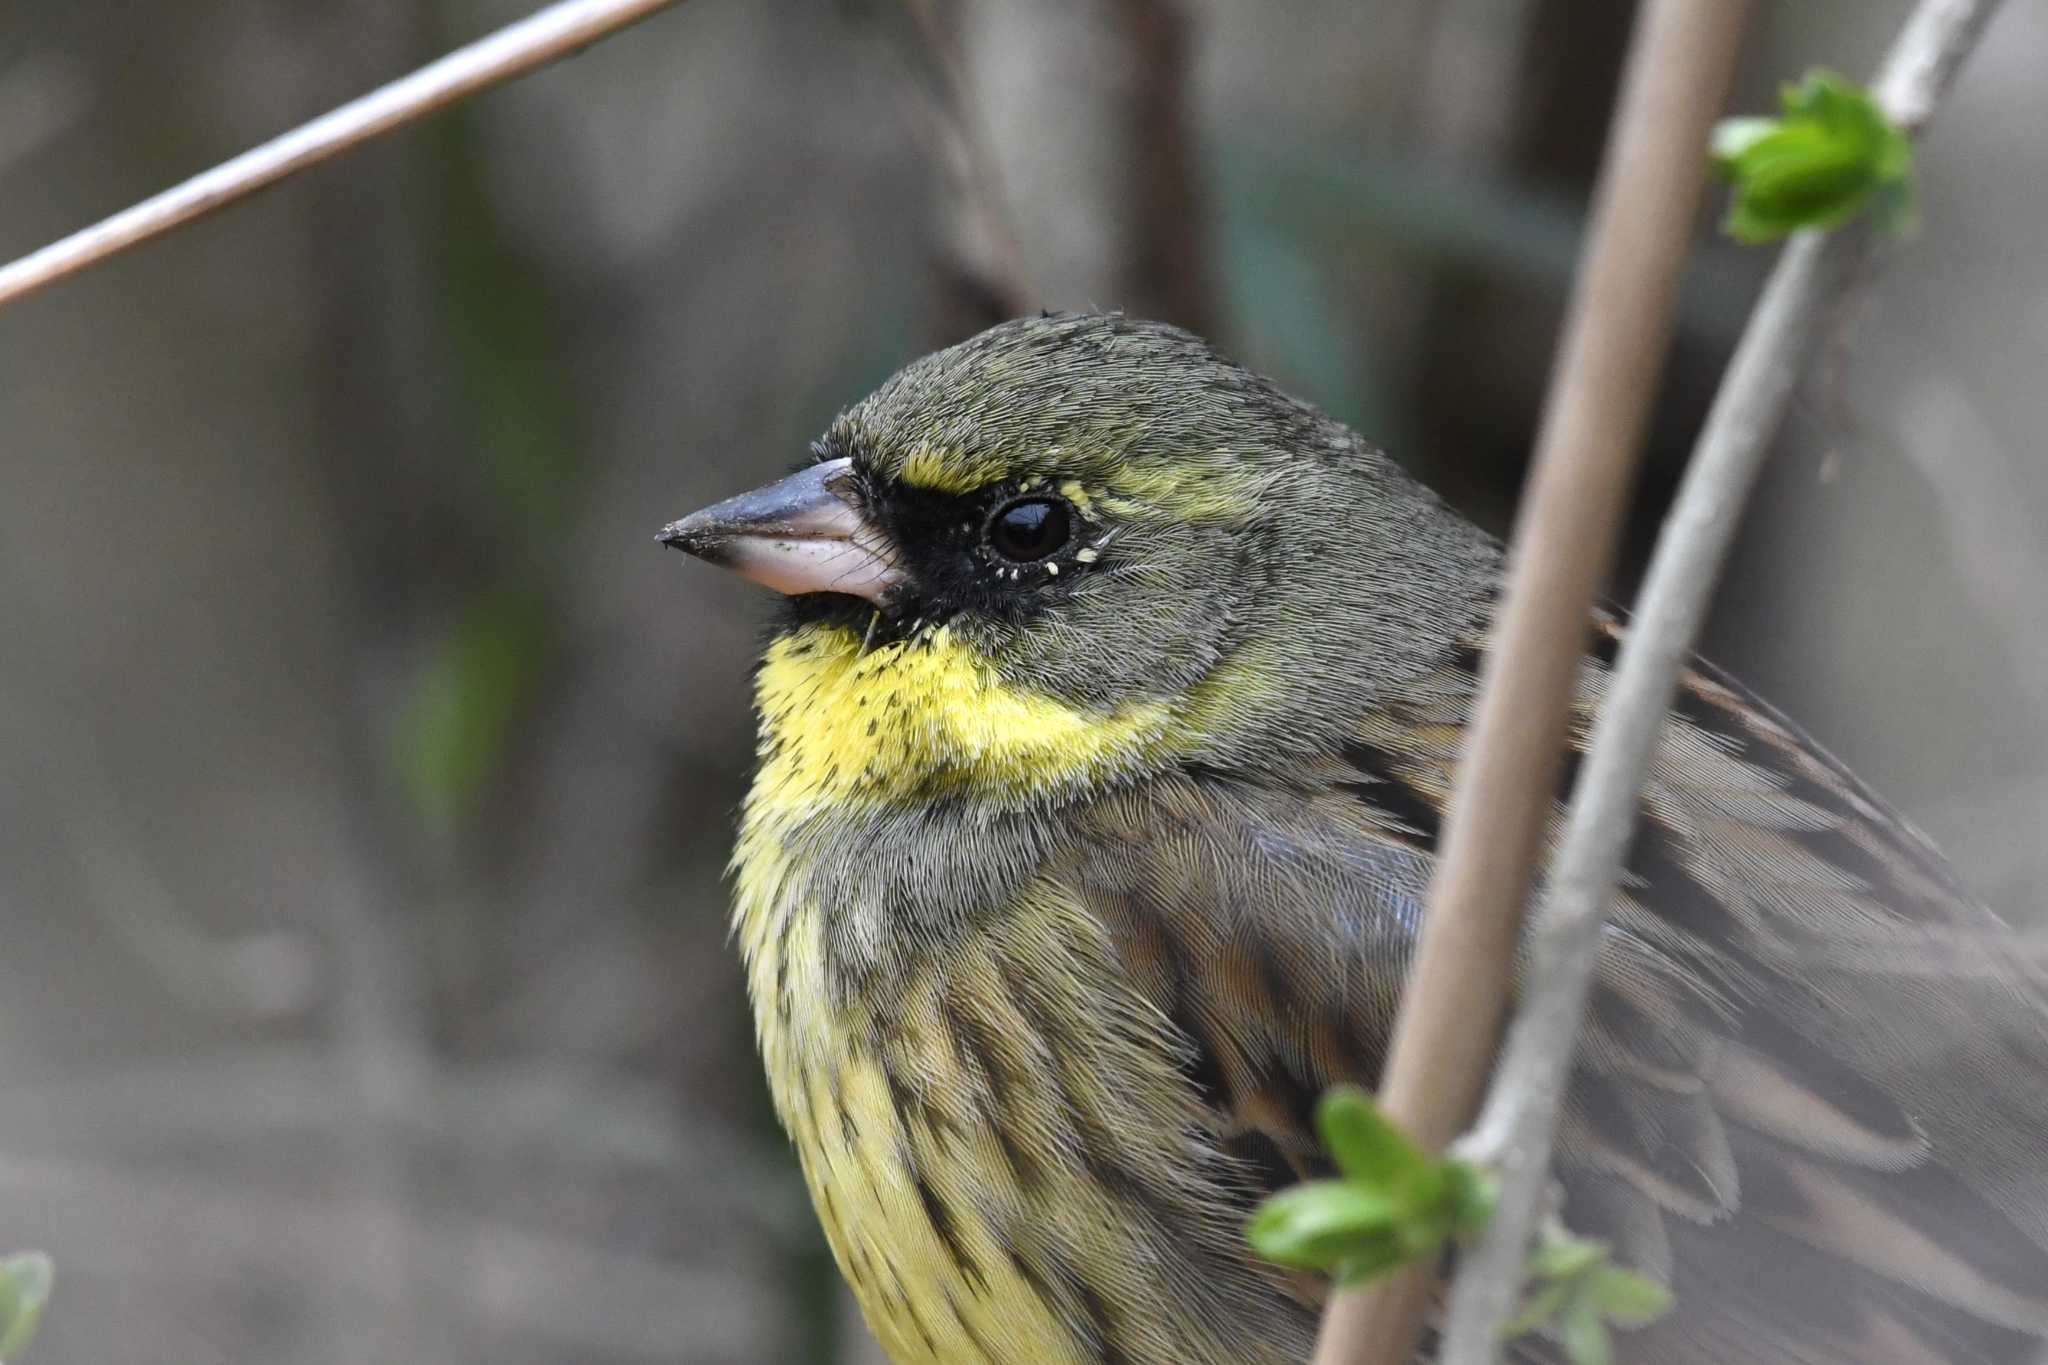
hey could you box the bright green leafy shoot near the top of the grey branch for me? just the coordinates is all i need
[1714,72,1915,244]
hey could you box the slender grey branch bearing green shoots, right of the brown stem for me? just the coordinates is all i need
[1442,0,1997,1365]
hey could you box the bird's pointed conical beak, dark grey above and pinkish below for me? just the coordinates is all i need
[662,460,905,604]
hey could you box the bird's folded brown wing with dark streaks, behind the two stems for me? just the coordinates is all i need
[1061,622,2048,1365]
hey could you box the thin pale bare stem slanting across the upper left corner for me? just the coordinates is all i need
[0,0,682,307]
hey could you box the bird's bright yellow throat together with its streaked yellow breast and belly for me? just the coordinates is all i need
[735,626,1302,1365]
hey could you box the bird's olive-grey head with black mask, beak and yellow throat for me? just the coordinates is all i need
[662,315,1491,796]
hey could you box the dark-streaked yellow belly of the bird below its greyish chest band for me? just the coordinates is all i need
[733,875,1298,1365]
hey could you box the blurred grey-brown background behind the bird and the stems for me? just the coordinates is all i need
[0,0,2048,1365]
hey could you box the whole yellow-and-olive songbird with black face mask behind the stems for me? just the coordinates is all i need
[664,315,2048,1365]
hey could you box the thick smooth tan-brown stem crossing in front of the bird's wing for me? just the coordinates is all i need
[1315,0,1747,1365]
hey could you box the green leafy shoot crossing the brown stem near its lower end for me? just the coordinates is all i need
[1245,1087,1493,1285]
